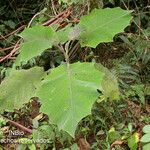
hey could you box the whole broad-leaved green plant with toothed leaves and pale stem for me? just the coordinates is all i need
[0,5,131,141]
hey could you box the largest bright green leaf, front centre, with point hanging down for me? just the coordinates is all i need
[37,62,103,135]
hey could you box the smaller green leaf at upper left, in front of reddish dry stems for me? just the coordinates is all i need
[17,26,56,62]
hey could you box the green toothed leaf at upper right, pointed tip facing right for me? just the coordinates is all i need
[79,8,131,48]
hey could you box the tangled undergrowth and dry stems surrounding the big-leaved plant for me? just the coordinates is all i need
[0,0,150,150]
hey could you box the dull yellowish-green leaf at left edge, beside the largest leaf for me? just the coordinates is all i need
[0,67,44,111]
